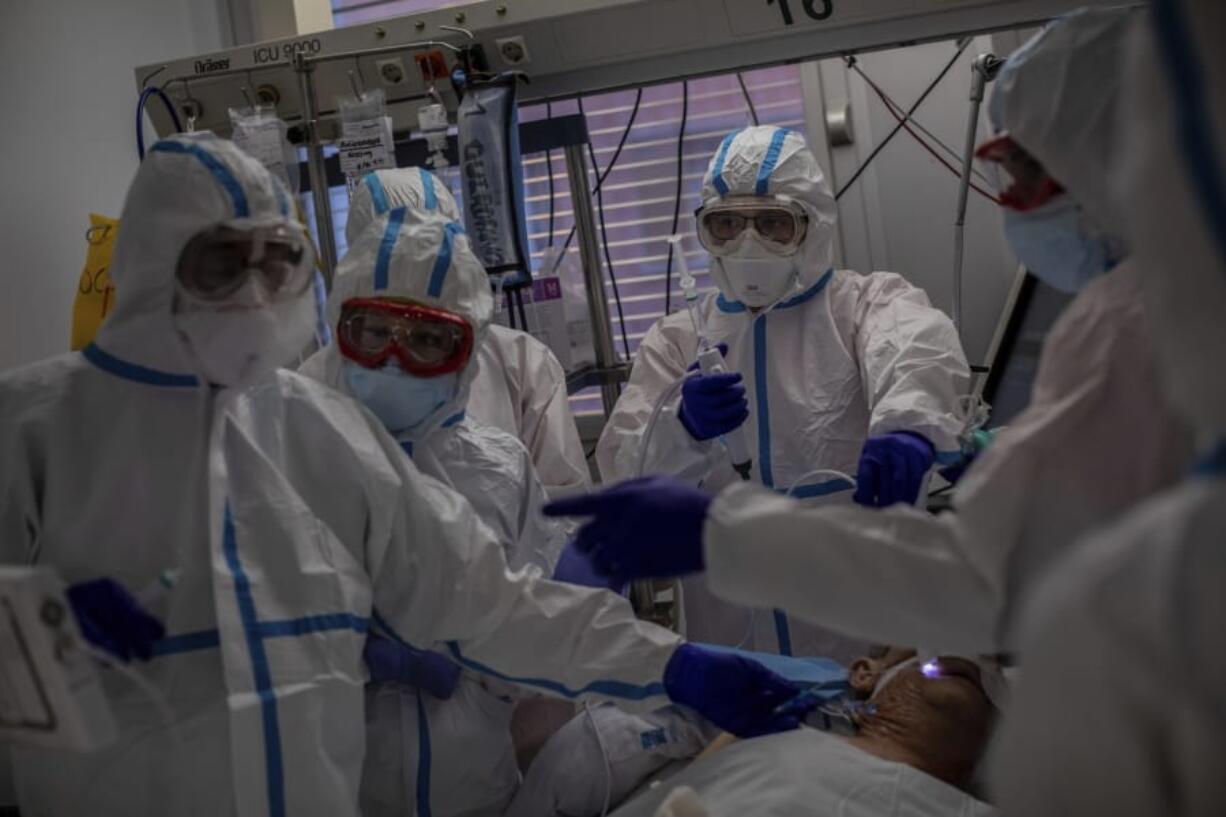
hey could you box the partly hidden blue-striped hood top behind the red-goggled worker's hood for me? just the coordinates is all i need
[345,167,461,247]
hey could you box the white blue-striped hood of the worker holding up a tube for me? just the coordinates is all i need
[702,125,837,301]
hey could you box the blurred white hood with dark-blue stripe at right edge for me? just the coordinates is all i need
[1117,0,1226,444]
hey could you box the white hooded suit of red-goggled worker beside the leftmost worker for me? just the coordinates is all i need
[302,207,566,817]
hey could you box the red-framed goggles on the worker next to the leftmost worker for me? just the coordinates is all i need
[336,298,473,378]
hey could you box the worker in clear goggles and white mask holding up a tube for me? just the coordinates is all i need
[596,126,970,660]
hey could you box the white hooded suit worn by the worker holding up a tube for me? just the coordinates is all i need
[596,128,970,660]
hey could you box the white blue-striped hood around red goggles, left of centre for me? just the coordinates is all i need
[302,209,494,439]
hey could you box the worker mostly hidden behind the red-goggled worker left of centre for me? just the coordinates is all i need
[345,168,591,497]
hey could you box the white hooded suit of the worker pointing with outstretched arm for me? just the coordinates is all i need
[705,10,1190,654]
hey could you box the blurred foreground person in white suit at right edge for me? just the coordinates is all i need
[992,0,1226,817]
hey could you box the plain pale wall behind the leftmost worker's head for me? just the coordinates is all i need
[0,0,228,370]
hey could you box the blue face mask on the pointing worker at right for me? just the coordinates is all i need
[1004,195,1118,293]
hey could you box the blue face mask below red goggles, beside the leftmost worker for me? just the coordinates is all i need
[341,361,460,434]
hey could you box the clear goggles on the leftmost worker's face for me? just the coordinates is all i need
[174,218,315,303]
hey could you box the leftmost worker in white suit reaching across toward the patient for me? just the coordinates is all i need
[0,135,794,816]
